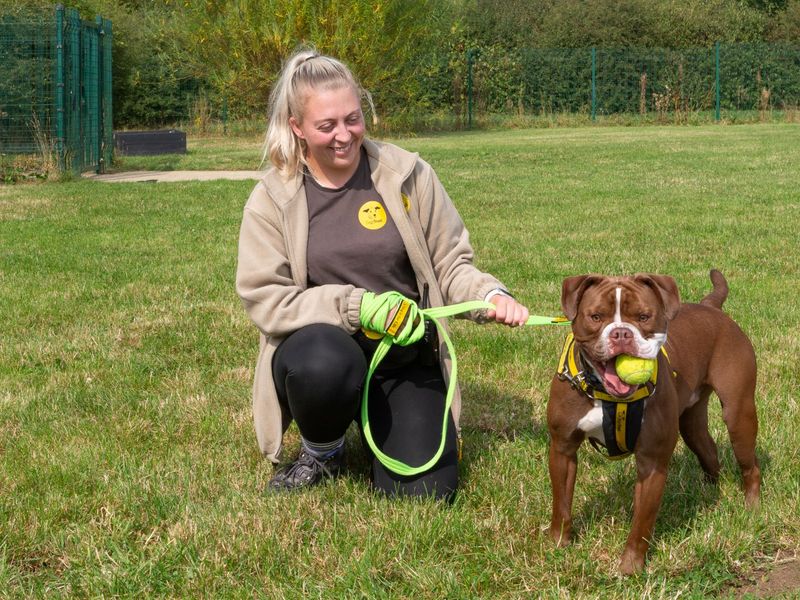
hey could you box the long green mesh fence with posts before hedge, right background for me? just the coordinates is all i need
[466,44,800,123]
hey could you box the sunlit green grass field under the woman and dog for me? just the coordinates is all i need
[0,124,800,599]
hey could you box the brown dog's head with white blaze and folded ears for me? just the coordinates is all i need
[561,273,680,397]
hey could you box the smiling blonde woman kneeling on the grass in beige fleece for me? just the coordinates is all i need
[236,50,528,498]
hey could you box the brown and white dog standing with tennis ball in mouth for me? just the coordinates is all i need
[547,270,761,574]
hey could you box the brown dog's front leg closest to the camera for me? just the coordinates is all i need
[619,454,669,575]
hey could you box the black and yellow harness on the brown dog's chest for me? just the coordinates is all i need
[558,333,669,460]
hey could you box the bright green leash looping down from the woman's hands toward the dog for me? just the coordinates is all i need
[361,300,570,477]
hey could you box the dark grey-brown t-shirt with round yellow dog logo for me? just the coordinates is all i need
[304,149,419,302]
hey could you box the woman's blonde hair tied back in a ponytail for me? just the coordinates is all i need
[261,49,376,177]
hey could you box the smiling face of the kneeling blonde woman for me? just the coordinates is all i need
[289,86,366,187]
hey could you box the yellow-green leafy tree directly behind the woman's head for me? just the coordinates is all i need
[165,0,454,120]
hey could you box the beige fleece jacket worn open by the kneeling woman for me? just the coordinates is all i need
[236,139,504,462]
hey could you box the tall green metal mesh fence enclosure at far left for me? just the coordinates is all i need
[0,5,114,173]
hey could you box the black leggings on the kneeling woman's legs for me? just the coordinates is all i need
[272,324,458,499]
